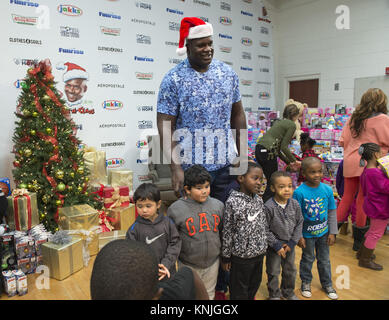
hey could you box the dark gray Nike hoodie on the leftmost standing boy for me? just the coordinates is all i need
[126,213,181,275]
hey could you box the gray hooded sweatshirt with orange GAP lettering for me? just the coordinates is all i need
[167,197,224,269]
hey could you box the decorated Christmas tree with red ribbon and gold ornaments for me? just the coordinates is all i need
[12,59,102,231]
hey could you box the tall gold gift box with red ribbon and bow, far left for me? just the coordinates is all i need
[7,189,39,231]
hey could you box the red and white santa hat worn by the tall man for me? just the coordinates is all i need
[176,17,213,56]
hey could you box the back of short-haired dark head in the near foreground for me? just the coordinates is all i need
[90,239,158,300]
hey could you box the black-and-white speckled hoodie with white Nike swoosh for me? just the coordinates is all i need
[222,190,269,262]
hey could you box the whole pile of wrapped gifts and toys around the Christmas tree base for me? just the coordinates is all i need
[0,149,136,297]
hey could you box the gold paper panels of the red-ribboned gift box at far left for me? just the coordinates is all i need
[7,192,39,231]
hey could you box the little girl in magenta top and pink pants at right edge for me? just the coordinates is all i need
[357,143,389,270]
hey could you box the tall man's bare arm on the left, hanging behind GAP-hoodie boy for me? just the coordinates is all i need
[157,112,184,198]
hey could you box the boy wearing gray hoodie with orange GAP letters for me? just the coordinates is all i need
[167,165,224,300]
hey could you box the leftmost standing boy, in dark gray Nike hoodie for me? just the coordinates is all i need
[126,183,181,280]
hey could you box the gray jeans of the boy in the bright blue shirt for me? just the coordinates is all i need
[300,232,332,288]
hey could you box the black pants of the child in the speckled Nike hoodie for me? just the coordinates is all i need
[230,254,265,300]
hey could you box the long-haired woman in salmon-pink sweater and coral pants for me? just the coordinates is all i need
[337,88,389,251]
